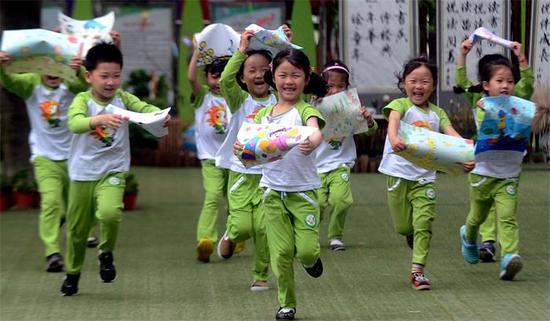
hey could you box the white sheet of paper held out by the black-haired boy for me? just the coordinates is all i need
[105,105,172,137]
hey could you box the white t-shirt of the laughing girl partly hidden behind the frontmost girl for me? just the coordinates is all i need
[216,94,277,174]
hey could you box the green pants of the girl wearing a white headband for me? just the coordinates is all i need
[317,167,353,240]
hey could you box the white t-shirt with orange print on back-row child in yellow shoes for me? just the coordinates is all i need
[193,86,231,160]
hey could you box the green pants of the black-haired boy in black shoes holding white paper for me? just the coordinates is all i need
[65,173,126,274]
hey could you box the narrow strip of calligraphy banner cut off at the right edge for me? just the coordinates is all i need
[531,0,550,87]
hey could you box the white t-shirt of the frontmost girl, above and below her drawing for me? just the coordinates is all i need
[255,101,324,192]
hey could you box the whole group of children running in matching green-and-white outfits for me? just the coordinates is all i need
[0,21,533,320]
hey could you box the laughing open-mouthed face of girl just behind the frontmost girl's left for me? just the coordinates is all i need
[241,54,269,97]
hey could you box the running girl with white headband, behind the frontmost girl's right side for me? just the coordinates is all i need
[314,60,378,251]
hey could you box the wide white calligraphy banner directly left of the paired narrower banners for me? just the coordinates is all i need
[341,0,419,93]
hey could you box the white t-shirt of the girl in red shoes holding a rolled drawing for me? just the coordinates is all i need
[378,98,451,182]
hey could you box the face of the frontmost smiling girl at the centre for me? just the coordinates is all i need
[273,60,307,103]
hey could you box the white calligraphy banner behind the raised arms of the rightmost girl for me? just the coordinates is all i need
[436,0,510,91]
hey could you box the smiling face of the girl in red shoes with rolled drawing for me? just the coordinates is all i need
[403,65,435,107]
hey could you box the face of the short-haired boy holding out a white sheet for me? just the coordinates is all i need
[86,62,122,101]
